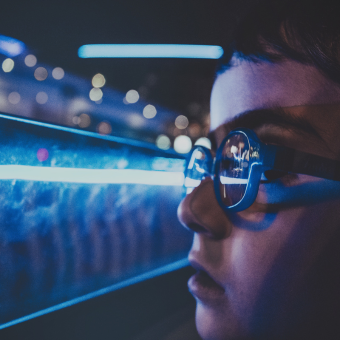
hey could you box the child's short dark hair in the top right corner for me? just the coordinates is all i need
[218,0,340,83]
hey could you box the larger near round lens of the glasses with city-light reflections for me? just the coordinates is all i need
[219,133,249,207]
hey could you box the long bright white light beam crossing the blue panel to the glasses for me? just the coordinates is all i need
[0,165,184,186]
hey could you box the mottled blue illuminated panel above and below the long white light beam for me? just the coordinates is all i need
[0,113,191,326]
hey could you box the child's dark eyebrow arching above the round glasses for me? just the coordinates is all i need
[208,107,320,150]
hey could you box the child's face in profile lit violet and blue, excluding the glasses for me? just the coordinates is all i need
[178,59,340,339]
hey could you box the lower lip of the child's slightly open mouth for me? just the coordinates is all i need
[188,270,225,302]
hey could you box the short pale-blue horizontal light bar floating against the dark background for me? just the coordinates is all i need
[78,44,223,59]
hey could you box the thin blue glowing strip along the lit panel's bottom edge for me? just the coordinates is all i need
[0,258,189,329]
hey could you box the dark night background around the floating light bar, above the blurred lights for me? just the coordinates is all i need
[0,0,252,124]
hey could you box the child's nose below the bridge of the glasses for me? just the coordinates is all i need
[177,178,232,239]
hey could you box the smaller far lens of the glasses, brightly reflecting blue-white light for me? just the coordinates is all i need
[184,147,210,191]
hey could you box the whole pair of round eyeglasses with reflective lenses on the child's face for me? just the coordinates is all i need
[184,129,340,212]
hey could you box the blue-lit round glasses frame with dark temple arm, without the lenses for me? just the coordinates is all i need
[185,128,340,212]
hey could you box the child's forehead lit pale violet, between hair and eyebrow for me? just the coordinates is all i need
[211,57,340,130]
